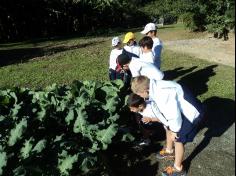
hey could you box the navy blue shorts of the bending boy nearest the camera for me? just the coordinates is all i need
[177,86,205,144]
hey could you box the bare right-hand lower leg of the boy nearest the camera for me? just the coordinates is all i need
[174,142,184,171]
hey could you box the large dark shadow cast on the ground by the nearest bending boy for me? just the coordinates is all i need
[184,97,235,171]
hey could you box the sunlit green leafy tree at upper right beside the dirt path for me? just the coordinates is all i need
[178,0,235,40]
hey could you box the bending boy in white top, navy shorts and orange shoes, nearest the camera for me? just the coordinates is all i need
[131,76,204,176]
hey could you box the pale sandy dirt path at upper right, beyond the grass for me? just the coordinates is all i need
[164,34,235,67]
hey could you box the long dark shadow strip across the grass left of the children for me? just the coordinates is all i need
[0,41,105,67]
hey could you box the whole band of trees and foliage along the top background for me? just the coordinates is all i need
[0,0,235,41]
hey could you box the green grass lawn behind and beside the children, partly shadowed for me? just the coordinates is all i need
[0,25,235,102]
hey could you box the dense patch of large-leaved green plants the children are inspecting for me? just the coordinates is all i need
[0,80,132,175]
